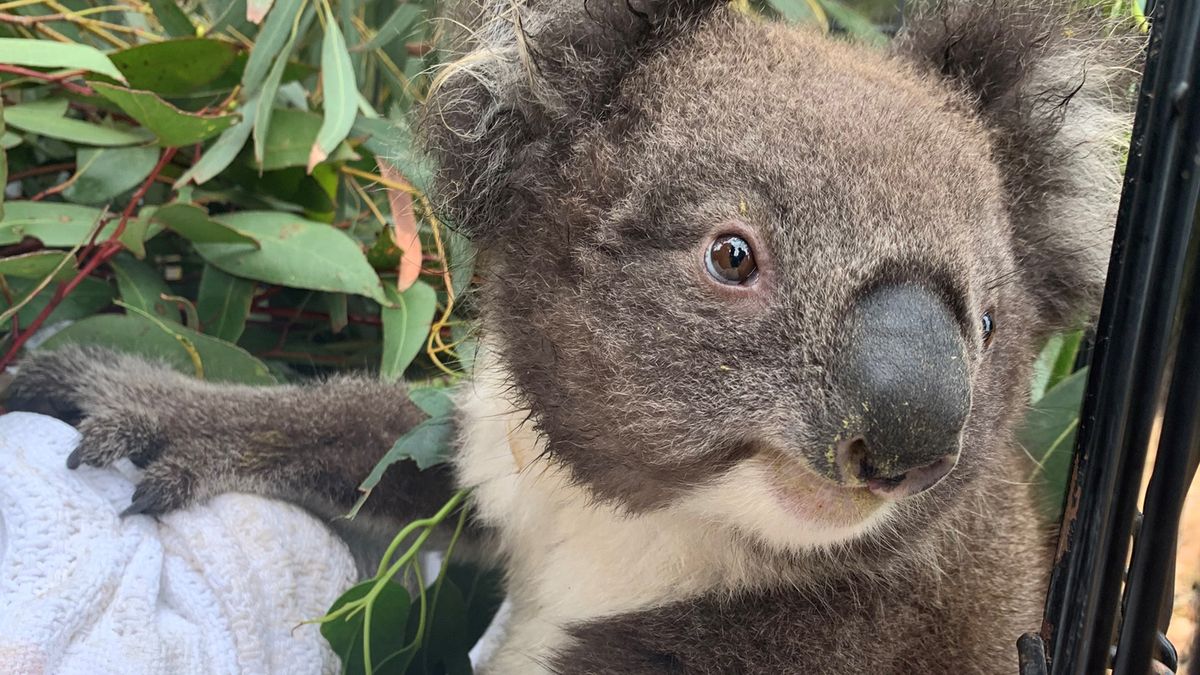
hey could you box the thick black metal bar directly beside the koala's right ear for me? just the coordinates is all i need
[1042,0,1200,675]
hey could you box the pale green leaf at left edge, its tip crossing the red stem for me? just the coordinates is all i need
[0,202,149,257]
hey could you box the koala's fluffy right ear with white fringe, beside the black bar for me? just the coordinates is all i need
[896,0,1144,331]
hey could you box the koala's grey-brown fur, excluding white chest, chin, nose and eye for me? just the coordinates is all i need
[2,0,1140,673]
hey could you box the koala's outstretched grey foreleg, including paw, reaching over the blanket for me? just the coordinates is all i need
[7,346,451,539]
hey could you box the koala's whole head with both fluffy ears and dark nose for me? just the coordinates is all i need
[424,0,1138,548]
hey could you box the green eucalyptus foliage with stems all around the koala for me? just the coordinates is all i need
[0,0,1140,673]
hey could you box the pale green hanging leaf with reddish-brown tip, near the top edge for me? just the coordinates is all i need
[307,5,359,173]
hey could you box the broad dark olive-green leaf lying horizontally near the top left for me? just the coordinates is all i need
[109,37,238,97]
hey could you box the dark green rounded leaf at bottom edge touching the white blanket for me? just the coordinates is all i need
[320,579,419,675]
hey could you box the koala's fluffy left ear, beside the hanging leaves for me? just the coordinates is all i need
[421,0,724,245]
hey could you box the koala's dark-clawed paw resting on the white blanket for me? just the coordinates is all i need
[6,347,213,515]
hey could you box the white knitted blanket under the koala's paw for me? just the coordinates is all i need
[0,413,356,675]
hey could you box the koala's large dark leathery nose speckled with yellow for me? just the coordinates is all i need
[834,281,971,498]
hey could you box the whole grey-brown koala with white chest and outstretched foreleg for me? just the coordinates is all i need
[8,0,1144,674]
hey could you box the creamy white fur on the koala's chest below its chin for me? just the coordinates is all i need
[457,371,762,674]
